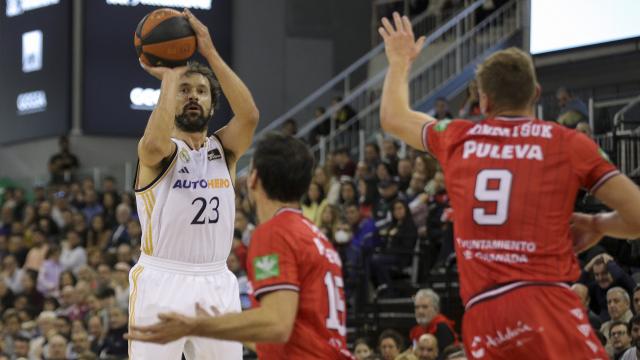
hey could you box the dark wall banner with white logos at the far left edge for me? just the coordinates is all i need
[0,0,71,144]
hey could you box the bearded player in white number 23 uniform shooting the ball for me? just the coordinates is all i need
[129,10,258,360]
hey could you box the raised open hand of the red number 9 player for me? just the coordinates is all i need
[378,12,426,64]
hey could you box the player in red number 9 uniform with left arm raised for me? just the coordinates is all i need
[379,13,640,360]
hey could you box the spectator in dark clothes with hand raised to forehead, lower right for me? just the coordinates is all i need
[578,253,636,320]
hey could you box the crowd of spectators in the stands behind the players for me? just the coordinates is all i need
[0,84,640,360]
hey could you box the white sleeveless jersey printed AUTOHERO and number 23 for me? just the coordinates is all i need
[136,136,236,264]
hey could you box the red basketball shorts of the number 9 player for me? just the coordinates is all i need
[462,283,608,360]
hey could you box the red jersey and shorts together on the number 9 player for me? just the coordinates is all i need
[423,116,619,359]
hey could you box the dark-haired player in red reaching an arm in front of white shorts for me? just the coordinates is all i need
[128,134,351,360]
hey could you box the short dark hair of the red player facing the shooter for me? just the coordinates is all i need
[253,133,314,202]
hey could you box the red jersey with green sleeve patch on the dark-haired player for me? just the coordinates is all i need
[247,209,350,359]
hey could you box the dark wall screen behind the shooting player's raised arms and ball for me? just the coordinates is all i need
[82,0,231,137]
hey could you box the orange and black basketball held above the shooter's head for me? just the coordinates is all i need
[134,9,197,67]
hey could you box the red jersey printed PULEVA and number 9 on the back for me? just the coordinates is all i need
[423,117,618,304]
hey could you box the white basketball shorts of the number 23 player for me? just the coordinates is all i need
[129,254,242,360]
